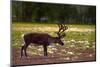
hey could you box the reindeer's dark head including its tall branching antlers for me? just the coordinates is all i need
[56,24,68,45]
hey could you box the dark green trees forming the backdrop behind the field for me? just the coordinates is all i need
[12,1,96,24]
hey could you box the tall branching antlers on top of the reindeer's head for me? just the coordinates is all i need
[57,24,68,38]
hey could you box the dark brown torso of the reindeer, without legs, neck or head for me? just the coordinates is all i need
[24,33,51,44]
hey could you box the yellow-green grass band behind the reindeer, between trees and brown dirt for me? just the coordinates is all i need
[12,23,96,48]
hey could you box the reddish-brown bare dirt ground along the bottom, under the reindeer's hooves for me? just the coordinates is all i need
[12,48,96,65]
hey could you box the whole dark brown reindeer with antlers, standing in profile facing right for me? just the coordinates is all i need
[21,24,68,58]
